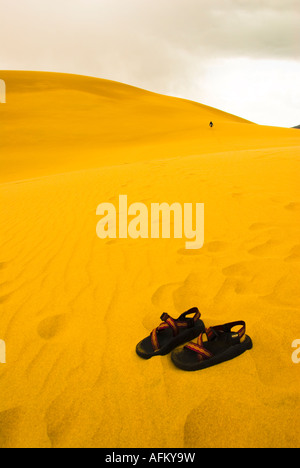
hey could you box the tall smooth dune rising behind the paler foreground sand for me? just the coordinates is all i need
[0,71,299,182]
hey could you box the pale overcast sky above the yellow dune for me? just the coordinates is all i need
[0,0,300,127]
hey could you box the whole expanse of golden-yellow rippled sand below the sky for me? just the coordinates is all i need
[0,72,300,448]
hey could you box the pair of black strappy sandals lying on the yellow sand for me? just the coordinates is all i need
[136,307,253,371]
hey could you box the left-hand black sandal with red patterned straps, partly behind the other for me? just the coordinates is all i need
[136,307,205,359]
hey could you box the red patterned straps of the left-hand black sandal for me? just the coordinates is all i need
[150,307,201,351]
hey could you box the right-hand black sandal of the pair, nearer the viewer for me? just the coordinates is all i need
[171,321,253,371]
